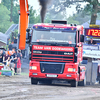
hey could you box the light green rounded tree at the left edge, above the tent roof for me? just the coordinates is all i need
[0,4,13,33]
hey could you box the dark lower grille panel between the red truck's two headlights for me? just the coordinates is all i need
[40,62,65,74]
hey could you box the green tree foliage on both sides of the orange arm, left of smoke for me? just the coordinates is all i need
[0,0,41,33]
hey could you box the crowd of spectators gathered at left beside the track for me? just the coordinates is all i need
[0,48,22,75]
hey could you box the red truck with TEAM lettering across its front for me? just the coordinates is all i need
[29,21,86,87]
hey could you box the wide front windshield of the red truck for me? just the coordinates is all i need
[32,30,76,44]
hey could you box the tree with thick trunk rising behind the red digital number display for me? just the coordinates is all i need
[51,0,100,24]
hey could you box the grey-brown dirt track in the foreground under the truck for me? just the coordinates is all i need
[0,75,100,100]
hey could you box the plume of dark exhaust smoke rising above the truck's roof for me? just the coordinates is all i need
[39,0,51,23]
